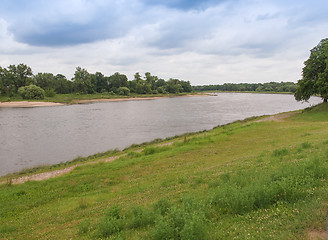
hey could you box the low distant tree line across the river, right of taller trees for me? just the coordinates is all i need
[193,82,297,93]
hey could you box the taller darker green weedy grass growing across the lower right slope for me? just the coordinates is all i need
[91,142,328,239]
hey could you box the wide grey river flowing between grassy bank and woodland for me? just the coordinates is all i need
[0,93,321,176]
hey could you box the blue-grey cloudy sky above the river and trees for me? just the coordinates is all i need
[0,0,328,85]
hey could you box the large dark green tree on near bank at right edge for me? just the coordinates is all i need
[295,38,328,102]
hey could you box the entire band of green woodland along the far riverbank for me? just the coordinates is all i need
[0,64,297,99]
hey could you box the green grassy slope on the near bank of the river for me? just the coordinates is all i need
[0,104,328,239]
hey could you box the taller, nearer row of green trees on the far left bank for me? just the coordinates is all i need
[0,64,192,96]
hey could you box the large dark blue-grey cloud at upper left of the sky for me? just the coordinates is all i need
[0,1,139,46]
